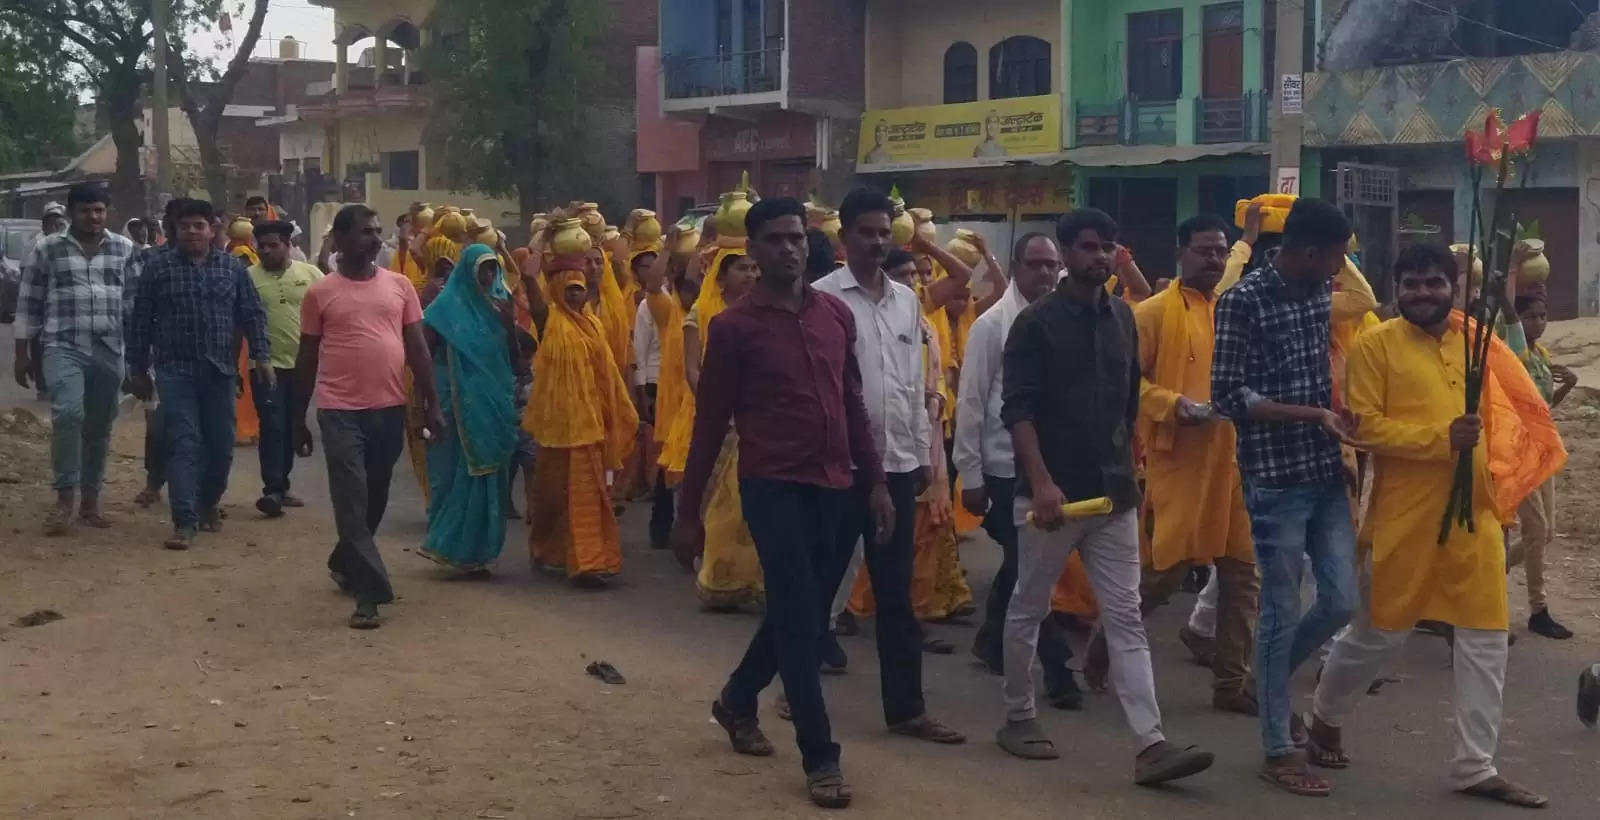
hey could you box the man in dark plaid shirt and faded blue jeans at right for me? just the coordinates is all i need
[1211,199,1357,794]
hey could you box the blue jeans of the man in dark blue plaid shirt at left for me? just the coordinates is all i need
[155,365,235,530]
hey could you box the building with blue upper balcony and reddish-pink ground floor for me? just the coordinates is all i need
[634,0,866,219]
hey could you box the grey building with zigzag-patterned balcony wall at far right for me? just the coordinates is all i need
[1302,0,1600,319]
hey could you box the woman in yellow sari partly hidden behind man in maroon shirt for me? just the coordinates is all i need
[667,237,766,612]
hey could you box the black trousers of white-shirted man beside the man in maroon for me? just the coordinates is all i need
[821,472,926,726]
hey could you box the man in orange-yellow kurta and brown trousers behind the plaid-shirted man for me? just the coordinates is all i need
[1132,216,1261,714]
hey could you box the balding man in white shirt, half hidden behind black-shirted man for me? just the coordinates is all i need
[952,232,1083,708]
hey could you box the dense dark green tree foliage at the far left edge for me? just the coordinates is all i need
[0,18,77,173]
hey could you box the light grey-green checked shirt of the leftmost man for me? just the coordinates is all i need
[16,231,134,354]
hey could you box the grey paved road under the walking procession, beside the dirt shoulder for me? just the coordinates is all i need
[0,323,1600,820]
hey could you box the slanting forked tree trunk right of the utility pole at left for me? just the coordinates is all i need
[168,0,267,208]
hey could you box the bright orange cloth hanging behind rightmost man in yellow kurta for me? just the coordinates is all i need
[1446,311,1566,522]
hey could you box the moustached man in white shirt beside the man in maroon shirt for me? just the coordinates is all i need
[813,189,966,743]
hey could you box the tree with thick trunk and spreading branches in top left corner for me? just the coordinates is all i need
[0,0,152,213]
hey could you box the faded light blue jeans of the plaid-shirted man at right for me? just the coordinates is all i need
[1245,477,1357,758]
